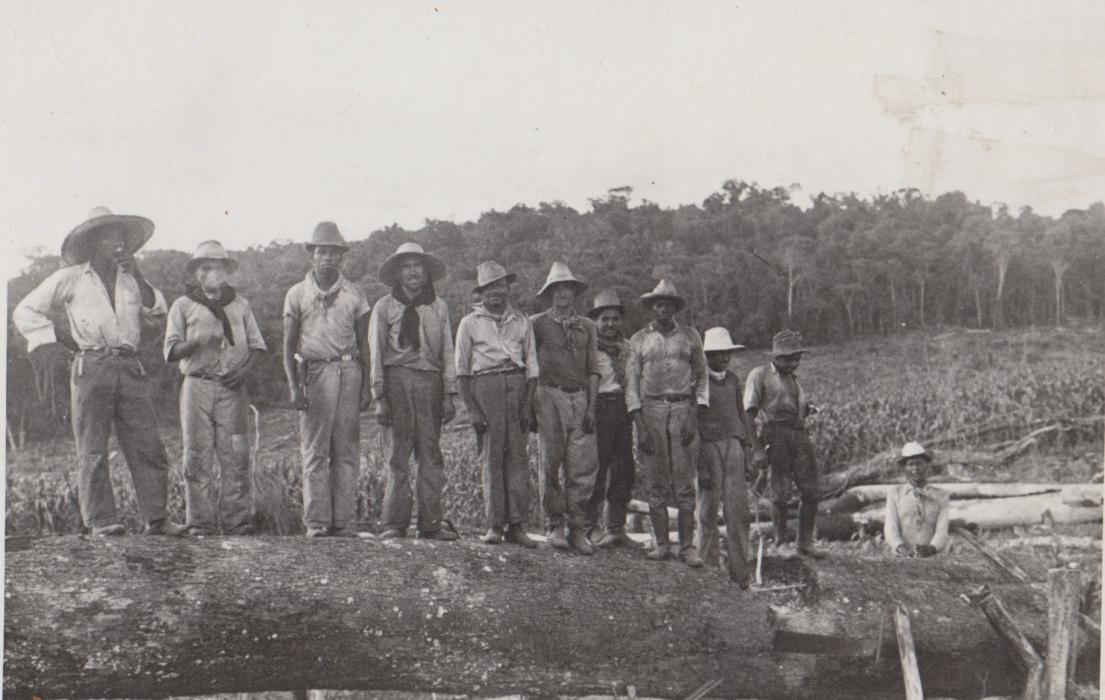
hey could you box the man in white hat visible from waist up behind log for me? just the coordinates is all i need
[883,442,949,556]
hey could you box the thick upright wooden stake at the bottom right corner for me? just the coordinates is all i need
[1048,568,1082,700]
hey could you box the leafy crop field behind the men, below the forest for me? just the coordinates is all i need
[7,330,1105,535]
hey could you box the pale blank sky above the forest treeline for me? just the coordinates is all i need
[0,0,1105,276]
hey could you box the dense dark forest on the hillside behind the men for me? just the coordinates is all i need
[8,180,1105,439]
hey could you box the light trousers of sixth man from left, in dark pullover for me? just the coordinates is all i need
[534,386,599,530]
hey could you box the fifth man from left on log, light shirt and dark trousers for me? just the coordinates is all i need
[455,260,538,547]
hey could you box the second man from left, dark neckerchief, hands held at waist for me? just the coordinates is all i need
[165,241,266,535]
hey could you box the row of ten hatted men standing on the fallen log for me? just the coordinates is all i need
[13,209,835,585]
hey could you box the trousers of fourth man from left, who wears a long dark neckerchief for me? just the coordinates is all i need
[383,367,445,533]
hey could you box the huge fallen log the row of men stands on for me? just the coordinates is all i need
[3,536,1091,698]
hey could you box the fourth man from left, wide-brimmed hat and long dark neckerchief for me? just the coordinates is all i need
[368,243,456,541]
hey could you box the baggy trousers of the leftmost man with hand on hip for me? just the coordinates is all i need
[70,351,169,527]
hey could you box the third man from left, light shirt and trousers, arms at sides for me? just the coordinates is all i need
[284,221,372,537]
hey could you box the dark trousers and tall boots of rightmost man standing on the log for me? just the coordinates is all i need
[760,424,821,544]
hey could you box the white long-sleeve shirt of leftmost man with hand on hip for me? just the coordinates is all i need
[11,262,167,352]
